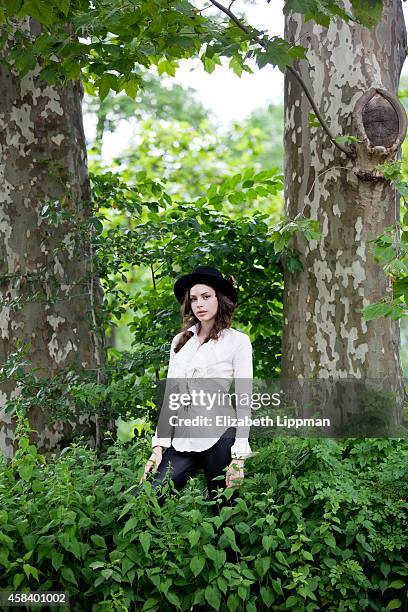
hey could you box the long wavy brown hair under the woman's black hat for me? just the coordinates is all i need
[174,276,236,353]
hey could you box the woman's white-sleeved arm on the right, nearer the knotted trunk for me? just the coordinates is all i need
[231,334,254,459]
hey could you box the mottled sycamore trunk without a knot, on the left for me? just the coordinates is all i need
[0,20,105,457]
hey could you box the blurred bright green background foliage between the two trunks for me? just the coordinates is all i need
[85,94,283,206]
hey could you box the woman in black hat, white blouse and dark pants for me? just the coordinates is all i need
[136,266,253,514]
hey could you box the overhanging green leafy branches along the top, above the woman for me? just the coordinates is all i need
[0,0,382,100]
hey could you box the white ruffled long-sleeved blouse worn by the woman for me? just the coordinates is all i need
[152,325,255,459]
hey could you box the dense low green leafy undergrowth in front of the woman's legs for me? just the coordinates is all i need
[0,419,408,612]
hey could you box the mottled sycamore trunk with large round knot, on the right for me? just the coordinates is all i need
[282,0,406,428]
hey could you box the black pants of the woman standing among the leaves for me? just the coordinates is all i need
[134,428,238,516]
